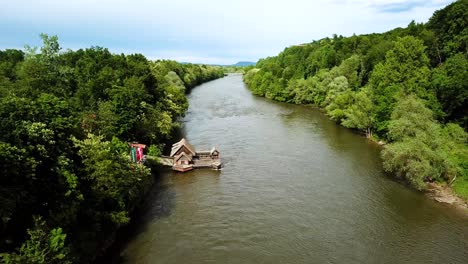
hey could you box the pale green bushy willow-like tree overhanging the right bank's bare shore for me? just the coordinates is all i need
[382,95,467,190]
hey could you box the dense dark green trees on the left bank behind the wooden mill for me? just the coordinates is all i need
[0,35,223,263]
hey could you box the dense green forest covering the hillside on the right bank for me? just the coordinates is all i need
[244,0,468,196]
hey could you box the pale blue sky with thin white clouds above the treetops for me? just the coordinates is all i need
[0,0,453,65]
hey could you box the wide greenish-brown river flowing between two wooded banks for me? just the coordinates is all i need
[117,75,468,264]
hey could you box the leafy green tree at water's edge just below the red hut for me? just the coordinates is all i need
[74,134,150,226]
